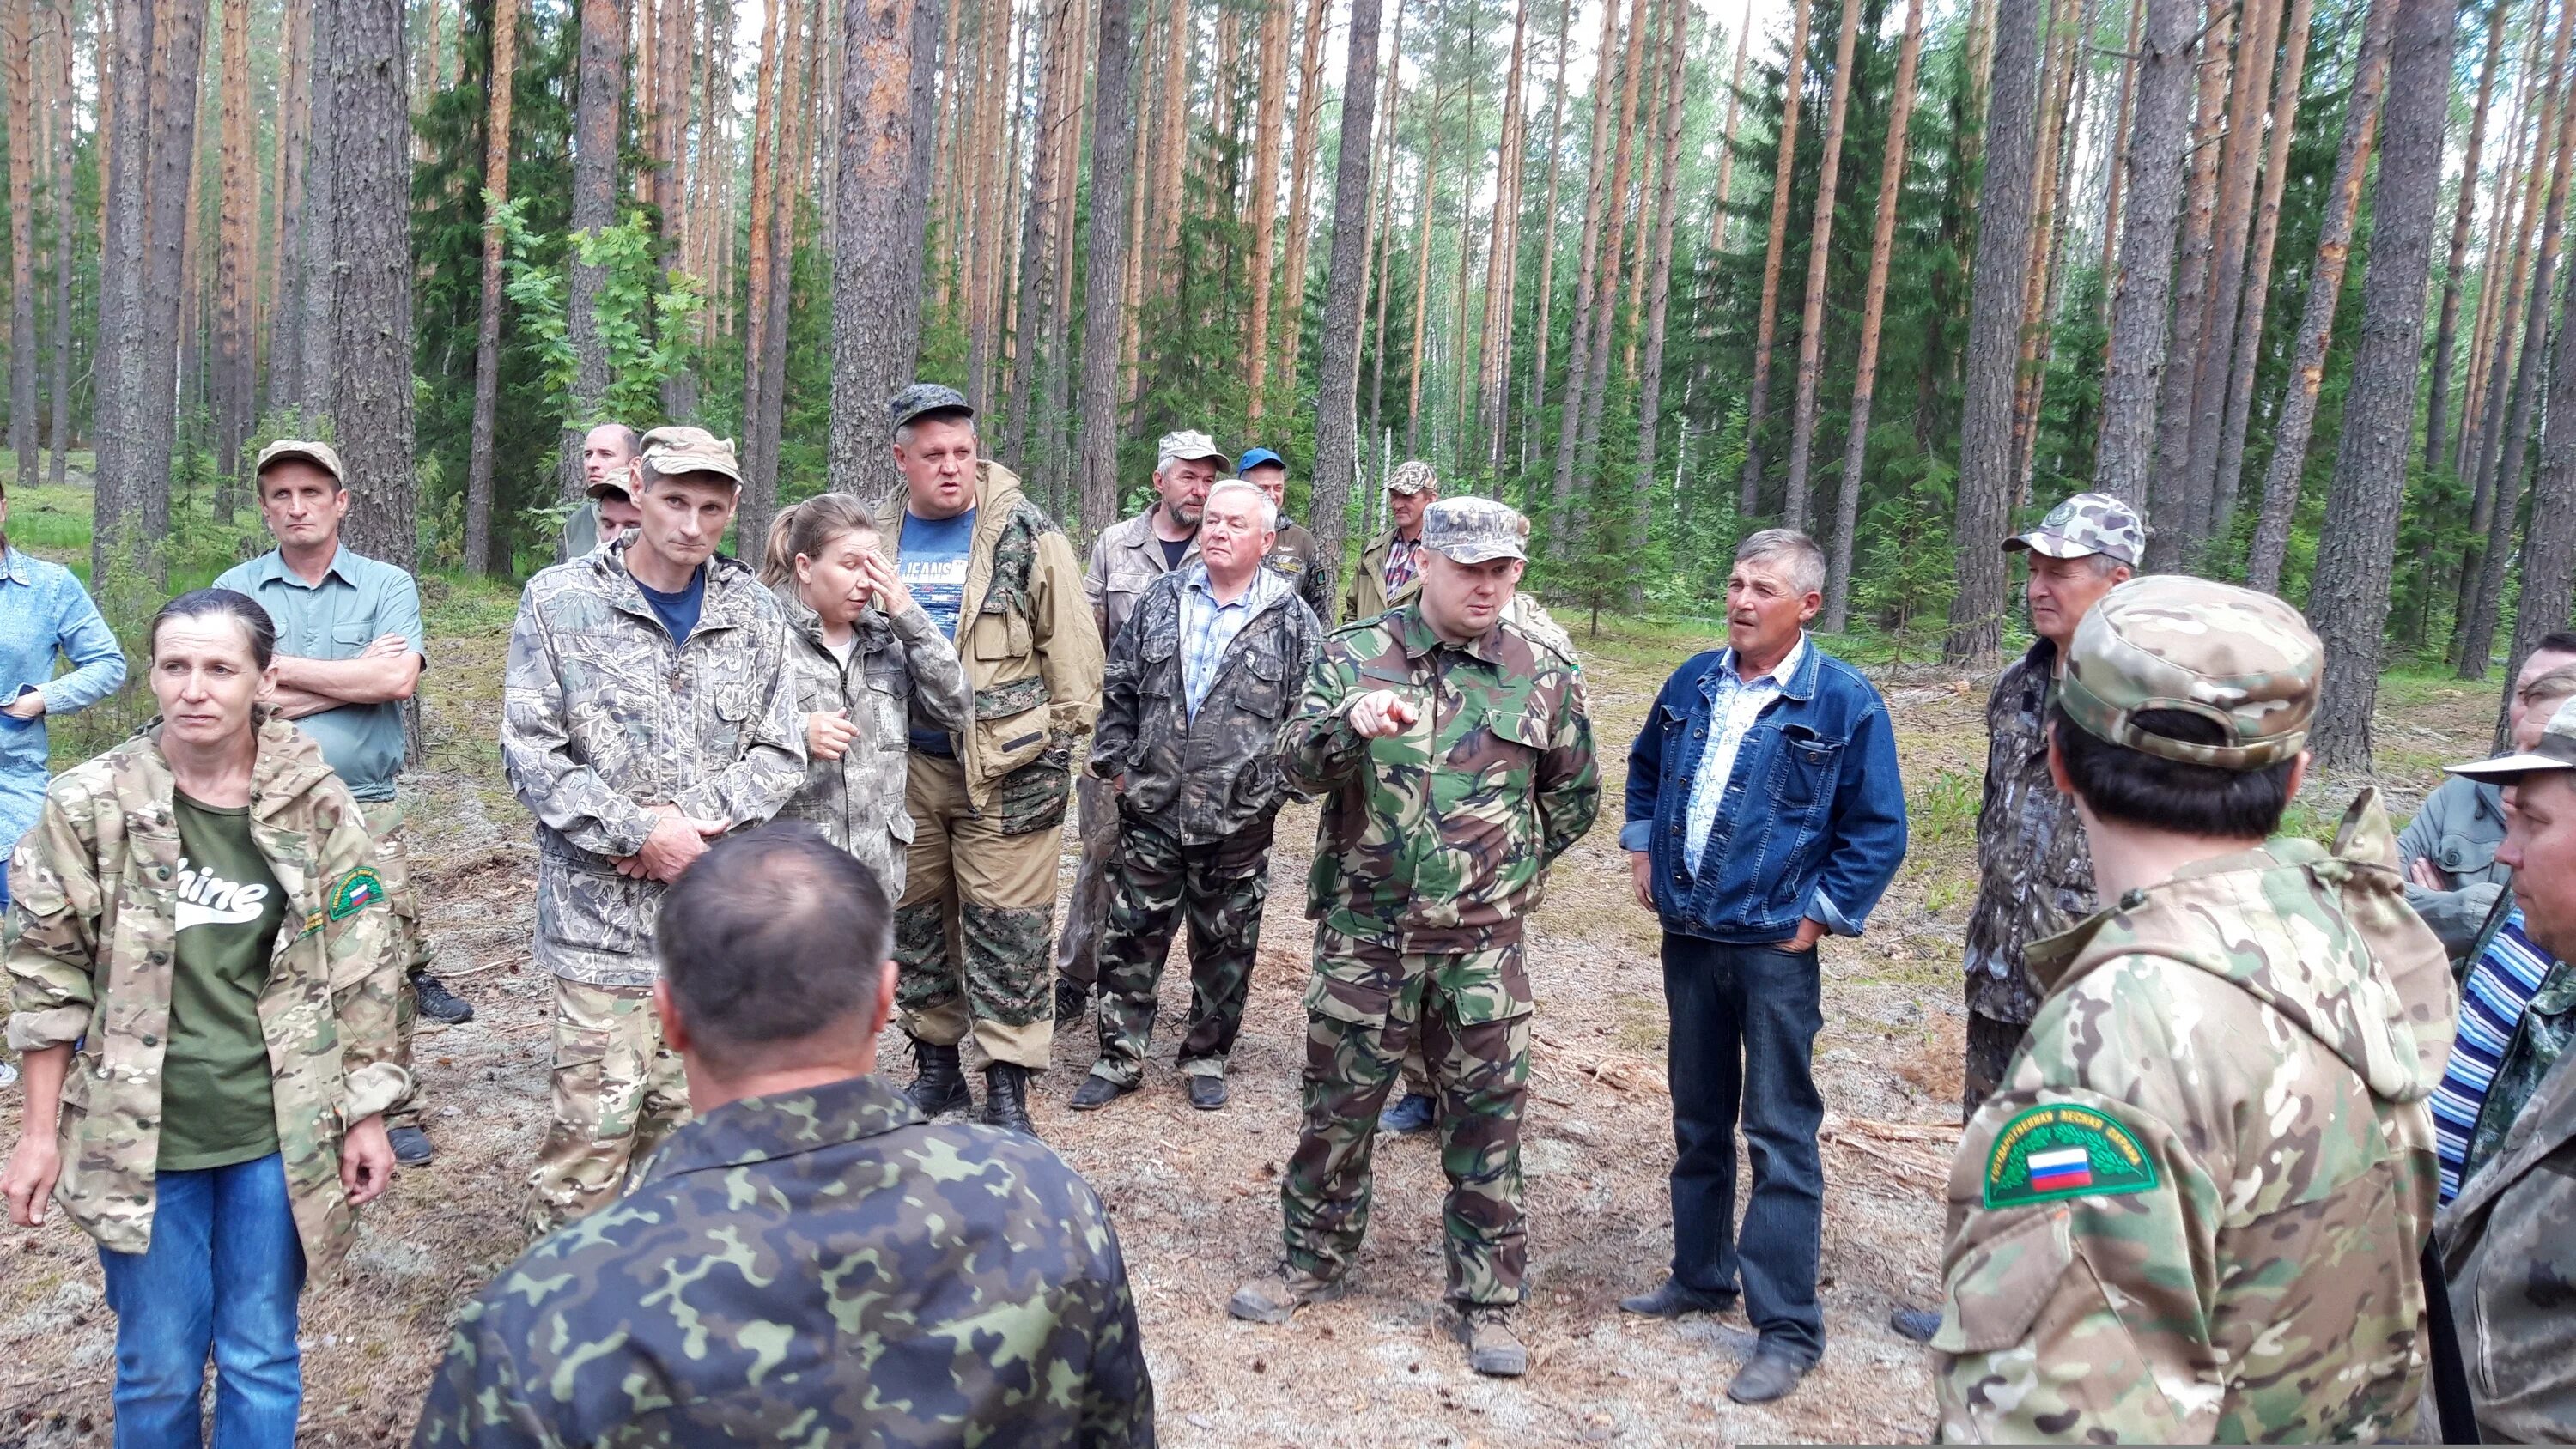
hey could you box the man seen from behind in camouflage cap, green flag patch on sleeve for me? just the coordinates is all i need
[1932,577,2452,1444]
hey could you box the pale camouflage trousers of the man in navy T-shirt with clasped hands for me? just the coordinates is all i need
[528,975,688,1240]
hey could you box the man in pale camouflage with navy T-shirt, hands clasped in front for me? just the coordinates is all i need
[500,427,806,1238]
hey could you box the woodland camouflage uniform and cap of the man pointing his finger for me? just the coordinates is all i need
[1280,500,1600,1307]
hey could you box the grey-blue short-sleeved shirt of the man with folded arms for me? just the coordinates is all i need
[214,543,430,800]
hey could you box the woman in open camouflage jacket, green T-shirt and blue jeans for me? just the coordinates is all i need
[0,590,410,1444]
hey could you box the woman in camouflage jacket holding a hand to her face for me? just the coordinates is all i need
[760,494,974,900]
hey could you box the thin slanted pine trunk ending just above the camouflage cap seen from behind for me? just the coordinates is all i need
[2246,0,2391,592]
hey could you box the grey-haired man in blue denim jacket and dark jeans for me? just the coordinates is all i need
[1620,528,1906,1403]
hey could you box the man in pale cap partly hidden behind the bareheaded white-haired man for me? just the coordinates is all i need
[1056,430,1231,1022]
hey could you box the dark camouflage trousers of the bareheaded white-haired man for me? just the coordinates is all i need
[1092,813,1273,1086]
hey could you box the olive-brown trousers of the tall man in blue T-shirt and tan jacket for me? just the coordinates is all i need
[894,751,1064,1070]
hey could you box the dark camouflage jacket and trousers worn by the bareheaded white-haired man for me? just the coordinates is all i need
[1092,564,1321,1086]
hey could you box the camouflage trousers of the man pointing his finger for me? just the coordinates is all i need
[1280,926,1530,1305]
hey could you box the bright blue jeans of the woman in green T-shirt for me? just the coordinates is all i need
[98,1153,304,1449]
